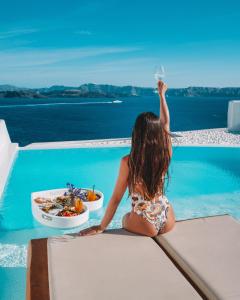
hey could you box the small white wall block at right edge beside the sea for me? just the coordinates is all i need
[228,100,240,132]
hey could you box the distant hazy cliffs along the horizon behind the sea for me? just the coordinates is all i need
[0,83,240,98]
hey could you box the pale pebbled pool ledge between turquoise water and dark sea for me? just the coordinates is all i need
[23,128,240,150]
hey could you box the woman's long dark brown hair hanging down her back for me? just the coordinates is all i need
[128,112,171,200]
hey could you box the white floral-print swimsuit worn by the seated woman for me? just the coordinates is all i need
[131,193,170,232]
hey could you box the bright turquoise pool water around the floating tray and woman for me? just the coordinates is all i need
[0,147,240,300]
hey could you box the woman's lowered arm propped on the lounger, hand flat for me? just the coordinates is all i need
[79,157,128,235]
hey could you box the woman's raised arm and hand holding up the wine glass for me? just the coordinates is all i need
[158,80,170,132]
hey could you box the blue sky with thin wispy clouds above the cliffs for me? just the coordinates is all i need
[0,0,240,87]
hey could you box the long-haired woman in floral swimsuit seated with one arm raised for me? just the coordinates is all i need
[79,81,175,237]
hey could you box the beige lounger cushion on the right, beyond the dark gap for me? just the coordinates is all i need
[155,215,240,300]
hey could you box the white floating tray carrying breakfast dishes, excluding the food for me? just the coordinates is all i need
[31,188,104,229]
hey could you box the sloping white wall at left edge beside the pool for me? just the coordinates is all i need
[0,120,18,198]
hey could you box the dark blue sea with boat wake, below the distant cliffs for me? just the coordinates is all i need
[0,95,233,146]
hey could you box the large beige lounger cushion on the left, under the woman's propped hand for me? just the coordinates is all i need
[48,230,201,300]
